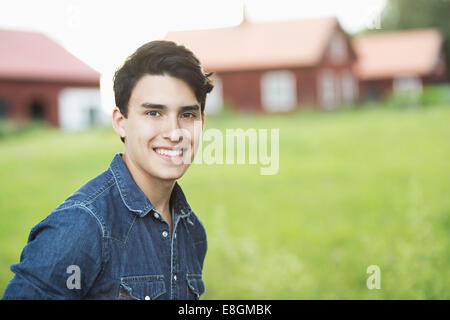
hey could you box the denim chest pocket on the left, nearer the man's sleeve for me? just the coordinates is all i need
[118,275,166,300]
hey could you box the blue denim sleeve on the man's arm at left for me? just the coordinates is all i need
[3,206,103,300]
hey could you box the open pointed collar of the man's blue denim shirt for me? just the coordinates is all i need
[109,153,192,218]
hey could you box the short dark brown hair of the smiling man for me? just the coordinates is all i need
[114,40,213,142]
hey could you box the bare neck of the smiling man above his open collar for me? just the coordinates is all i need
[122,153,176,213]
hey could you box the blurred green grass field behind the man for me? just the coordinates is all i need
[0,106,450,299]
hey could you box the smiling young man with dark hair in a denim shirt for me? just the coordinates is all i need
[3,41,213,300]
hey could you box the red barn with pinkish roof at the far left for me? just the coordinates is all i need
[0,30,100,127]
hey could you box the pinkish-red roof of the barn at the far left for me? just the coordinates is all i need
[0,29,100,84]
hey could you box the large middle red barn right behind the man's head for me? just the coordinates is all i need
[166,17,358,112]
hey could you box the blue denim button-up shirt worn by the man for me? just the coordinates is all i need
[3,154,207,300]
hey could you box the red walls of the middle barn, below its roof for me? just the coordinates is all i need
[215,26,358,112]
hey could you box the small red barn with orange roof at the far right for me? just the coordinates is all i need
[353,29,447,100]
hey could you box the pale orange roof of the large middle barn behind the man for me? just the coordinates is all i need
[165,17,338,71]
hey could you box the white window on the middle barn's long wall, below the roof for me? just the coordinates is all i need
[261,71,297,112]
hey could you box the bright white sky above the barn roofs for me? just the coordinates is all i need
[0,0,386,110]
